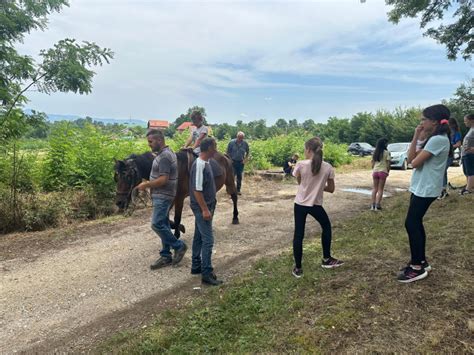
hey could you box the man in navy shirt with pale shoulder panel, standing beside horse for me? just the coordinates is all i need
[189,138,222,286]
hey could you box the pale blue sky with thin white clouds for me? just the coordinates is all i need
[20,0,474,124]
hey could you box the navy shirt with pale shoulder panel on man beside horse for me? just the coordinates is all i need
[189,158,216,210]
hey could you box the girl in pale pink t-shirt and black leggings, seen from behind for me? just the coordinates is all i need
[293,137,343,278]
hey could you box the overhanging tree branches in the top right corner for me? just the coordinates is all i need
[385,0,474,60]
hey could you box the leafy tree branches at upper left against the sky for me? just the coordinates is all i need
[0,0,113,139]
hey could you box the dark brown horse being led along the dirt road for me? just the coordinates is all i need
[115,150,239,238]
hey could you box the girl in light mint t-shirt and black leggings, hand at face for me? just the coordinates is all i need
[398,105,450,282]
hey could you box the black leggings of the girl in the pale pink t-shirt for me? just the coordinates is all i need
[293,203,331,269]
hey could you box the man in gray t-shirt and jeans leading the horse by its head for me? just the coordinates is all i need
[136,130,188,270]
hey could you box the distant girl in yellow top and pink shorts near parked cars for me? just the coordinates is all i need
[370,138,390,211]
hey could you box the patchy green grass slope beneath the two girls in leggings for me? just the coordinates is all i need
[100,194,474,353]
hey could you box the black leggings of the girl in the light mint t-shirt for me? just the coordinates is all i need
[405,194,436,265]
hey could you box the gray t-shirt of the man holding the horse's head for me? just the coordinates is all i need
[150,147,178,200]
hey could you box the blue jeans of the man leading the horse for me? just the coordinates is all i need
[151,197,183,258]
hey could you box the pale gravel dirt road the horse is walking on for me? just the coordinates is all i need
[0,168,460,353]
